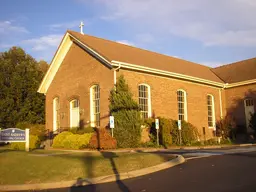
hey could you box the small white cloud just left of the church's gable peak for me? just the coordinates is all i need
[21,34,63,51]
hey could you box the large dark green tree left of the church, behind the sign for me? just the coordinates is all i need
[0,47,44,128]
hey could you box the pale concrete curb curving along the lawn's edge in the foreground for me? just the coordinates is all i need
[0,155,186,191]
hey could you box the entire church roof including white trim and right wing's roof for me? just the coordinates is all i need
[38,30,256,94]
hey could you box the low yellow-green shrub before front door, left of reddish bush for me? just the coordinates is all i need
[52,132,92,149]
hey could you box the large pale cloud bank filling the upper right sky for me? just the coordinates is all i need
[95,0,256,47]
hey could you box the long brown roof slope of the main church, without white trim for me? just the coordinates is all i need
[68,31,223,83]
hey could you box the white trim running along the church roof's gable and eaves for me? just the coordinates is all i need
[37,32,256,94]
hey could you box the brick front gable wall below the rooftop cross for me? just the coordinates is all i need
[46,44,114,130]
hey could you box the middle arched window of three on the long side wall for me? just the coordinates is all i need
[177,90,188,121]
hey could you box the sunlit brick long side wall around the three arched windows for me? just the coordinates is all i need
[118,70,223,138]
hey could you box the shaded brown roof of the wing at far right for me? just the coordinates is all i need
[212,57,256,83]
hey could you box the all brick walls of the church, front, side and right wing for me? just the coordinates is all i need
[46,41,256,138]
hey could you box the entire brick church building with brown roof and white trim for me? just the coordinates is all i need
[38,31,256,137]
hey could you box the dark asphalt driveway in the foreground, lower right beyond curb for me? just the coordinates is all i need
[34,152,256,192]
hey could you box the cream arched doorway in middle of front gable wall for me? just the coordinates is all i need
[70,99,80,128]
